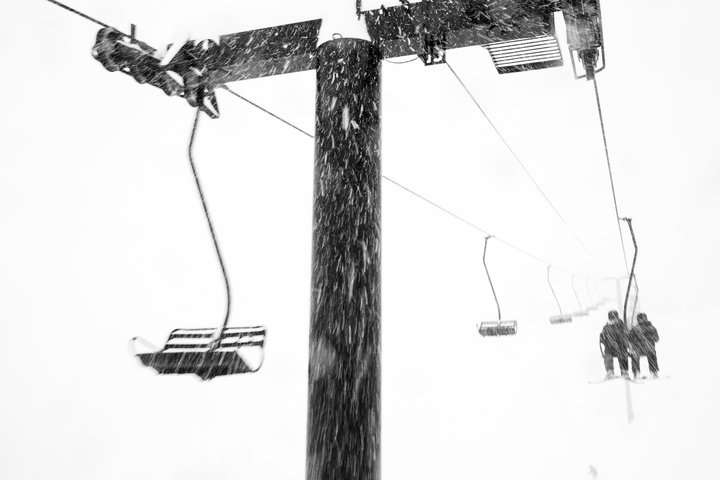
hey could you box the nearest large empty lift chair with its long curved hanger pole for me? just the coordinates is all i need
[132,109,265,380]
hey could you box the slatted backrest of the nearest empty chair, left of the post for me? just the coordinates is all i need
[163,327,265,353]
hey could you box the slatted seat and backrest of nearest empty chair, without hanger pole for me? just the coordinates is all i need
[136,327,265,380]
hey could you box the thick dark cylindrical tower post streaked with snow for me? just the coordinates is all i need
[306,38,381,480]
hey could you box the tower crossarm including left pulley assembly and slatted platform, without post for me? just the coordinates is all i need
[93,0,562,110]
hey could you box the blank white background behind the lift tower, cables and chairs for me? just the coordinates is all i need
[0,0,720,480]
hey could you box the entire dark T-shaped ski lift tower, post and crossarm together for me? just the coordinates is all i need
[77,0,604,480]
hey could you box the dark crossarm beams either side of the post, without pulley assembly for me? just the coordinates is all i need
[208,0,562,82]
